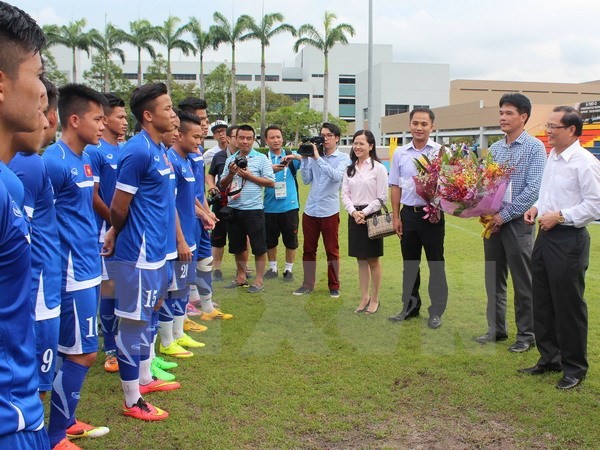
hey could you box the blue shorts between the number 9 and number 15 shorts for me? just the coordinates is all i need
[58,286,100,355]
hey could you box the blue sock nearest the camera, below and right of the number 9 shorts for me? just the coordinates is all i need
[48,359,88,448]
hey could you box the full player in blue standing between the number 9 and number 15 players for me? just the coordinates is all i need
[42,84,108,446]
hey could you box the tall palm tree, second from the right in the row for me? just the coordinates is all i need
[241,13,296,146]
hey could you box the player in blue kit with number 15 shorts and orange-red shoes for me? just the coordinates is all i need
[105,83,179,421]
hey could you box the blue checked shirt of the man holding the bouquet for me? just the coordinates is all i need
[490,131,546,223]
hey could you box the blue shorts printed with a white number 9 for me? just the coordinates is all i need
[35,317,60,392]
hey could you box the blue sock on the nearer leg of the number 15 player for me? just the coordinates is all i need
[117,319,147,381]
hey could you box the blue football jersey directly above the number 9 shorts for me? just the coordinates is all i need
[9,153,61,320]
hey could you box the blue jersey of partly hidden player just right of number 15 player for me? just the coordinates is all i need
[168,149,196,251]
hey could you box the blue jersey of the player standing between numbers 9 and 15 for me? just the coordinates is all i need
[42,140,102,291]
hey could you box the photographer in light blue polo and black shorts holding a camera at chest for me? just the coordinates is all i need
[219,125,275,294]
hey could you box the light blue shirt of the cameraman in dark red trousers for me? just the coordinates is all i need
[300,149,350,217]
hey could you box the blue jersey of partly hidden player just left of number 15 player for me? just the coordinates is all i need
[85,139,122,242]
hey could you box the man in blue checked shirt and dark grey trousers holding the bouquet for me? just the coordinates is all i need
[475,94,546,353]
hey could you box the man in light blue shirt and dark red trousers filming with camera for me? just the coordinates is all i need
[294,122,350,298]
